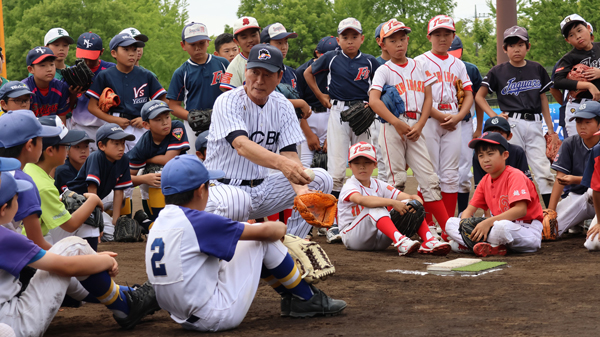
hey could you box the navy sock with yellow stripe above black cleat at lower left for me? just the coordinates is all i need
[81,271,129,315]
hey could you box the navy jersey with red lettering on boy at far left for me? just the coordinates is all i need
[21,76,71,117]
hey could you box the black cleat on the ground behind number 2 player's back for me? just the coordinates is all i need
[113,281,160,329]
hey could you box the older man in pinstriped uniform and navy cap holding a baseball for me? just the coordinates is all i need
[204,44,333,237]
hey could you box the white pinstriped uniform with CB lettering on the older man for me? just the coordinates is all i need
[204,87,336,237]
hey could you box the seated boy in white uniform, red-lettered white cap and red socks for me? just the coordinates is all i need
[338,142,450,256]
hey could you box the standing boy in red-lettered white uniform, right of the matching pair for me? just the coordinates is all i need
[415,15,473,227]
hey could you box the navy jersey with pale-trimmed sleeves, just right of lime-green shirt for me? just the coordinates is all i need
[67,151,133,199]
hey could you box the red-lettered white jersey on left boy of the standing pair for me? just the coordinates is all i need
[369,58,437,113]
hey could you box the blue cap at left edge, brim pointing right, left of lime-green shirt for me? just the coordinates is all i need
[0,110,62,148]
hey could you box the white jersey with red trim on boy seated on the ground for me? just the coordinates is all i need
[338,176,400,228]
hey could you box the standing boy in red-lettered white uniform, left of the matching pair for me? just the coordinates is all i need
[369,19,448,240]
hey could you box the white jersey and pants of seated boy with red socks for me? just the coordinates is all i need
[338,176,400,250]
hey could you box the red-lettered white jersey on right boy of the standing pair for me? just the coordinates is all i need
[415,51,472,112]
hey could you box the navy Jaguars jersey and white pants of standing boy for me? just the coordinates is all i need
[481,60,554,196]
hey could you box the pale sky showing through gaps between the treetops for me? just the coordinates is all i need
[188,0,489,35]
